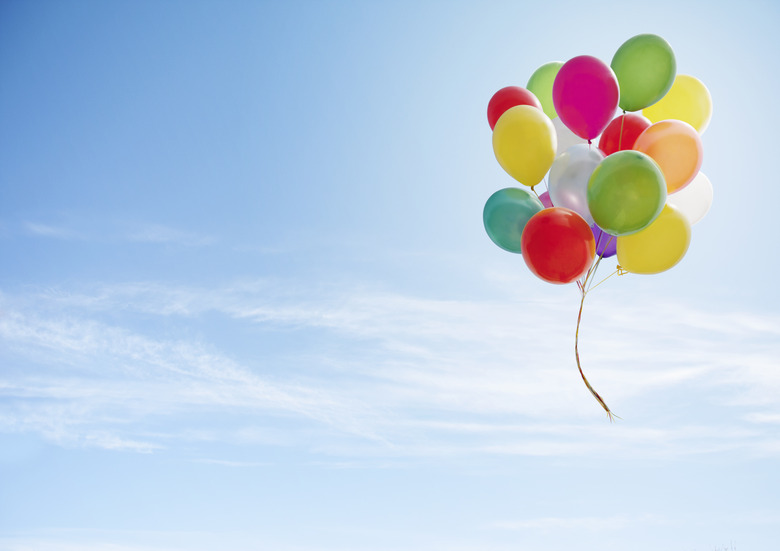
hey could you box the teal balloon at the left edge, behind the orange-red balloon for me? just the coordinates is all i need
[482,188,544,253]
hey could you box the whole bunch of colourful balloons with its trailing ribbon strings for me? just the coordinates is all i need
[483,34,713,419]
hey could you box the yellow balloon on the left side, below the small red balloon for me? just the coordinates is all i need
[493,105,557,187]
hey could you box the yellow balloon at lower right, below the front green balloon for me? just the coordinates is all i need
[617,205,691,274]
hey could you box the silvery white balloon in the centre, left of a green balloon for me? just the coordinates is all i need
[547,144,604,224]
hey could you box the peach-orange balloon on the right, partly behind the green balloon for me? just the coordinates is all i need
[634,119,703,193]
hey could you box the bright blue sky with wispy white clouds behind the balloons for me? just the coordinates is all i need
[0,0,780,551]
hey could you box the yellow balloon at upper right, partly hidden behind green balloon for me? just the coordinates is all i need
[642,75,712,134]
